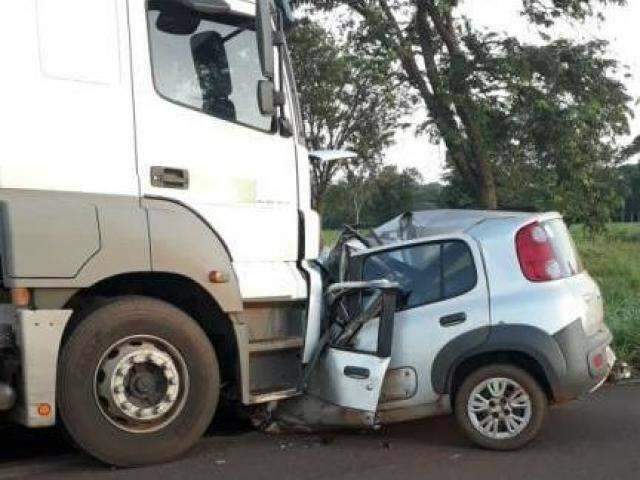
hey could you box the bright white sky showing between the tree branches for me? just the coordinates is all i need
[386,0,640,182]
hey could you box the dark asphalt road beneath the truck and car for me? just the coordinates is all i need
[0,384,640,480]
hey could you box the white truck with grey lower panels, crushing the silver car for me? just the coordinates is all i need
[0,0,322,464]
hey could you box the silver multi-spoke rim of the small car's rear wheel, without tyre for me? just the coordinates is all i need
[467,378,533,440]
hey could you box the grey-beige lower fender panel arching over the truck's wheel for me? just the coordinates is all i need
[0,190,243,312]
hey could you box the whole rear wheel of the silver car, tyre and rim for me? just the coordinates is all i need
[454,364,548,450]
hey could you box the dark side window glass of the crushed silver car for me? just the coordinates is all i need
[362,240,478,310]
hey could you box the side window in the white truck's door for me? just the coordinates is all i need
[147,4,273,131]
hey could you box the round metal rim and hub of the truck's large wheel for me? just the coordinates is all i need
[94,335,189,432]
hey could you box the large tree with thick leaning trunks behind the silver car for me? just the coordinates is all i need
[312,0,630,220]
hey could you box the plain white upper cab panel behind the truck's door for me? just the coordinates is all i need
[0,0,138,196]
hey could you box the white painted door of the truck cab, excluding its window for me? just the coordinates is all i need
[130,2,298,263]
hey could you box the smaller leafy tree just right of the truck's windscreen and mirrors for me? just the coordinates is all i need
[288,19,408,210]
